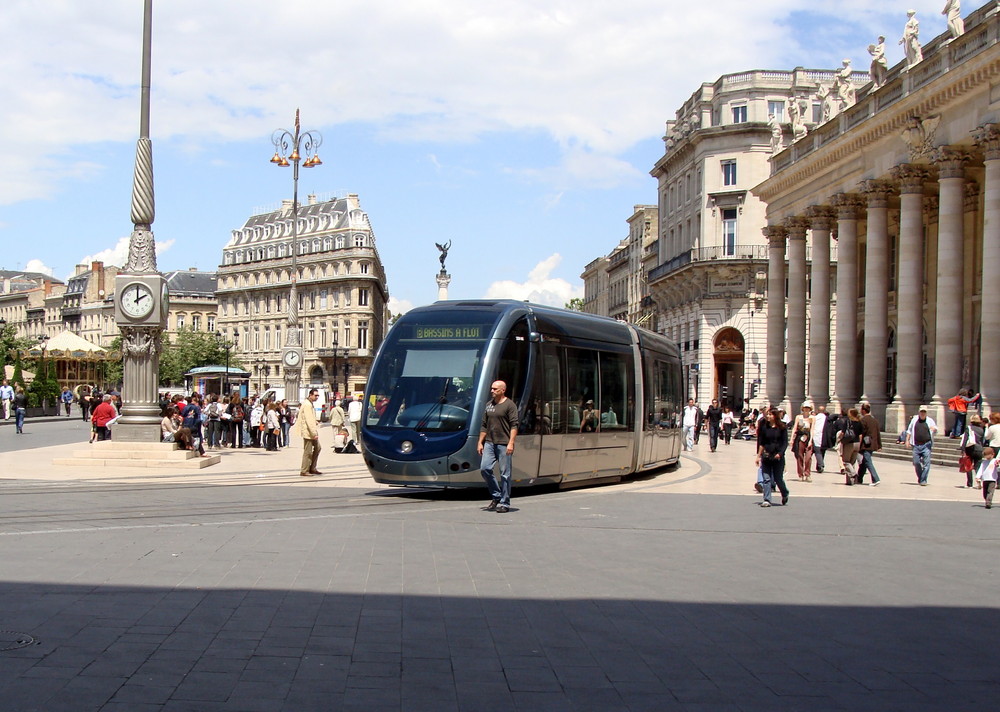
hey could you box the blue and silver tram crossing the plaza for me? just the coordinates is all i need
[361,300,684,487]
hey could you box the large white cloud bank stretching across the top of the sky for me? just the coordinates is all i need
[0,0,943,204]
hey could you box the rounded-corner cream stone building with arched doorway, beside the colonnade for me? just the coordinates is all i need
[647,68,867,409]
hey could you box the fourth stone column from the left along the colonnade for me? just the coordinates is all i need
[832,193,864,412]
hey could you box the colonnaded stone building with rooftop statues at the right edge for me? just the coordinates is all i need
[753,2,1000,432]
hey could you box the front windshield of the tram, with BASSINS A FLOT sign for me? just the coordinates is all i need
[366,312,497,432]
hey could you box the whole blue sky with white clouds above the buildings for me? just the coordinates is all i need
[0,0,956,313]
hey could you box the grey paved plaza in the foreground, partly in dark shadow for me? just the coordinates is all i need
[0,422,1000,712]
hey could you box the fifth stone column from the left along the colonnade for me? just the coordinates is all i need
[861,180,893,423]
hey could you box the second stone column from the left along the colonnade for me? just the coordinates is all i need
[785,217,809,413]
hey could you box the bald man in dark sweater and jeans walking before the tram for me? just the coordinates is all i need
[476,381,518,514]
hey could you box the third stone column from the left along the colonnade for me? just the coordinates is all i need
[806,205,834,408]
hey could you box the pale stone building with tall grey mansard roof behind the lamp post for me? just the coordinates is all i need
[216,194,389,392]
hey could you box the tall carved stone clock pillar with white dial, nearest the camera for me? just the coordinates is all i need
[115,0,169,442]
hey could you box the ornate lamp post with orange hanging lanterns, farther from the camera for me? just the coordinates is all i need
[271,109,323,408]
